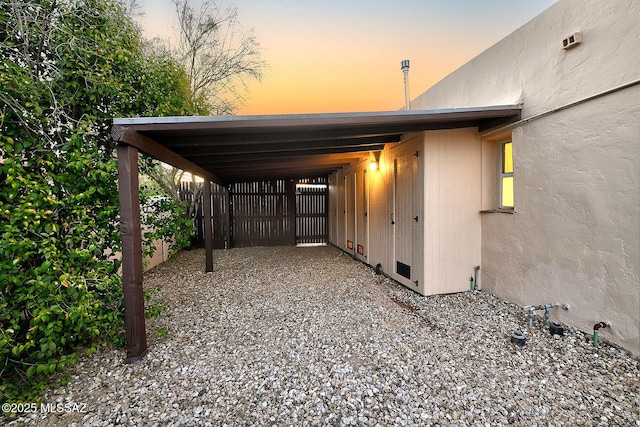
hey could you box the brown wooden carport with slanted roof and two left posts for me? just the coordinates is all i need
[112,105,520,363]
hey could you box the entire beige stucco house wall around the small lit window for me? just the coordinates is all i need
[412,0,640,354]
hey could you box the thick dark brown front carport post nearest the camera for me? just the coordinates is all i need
[118,144,147,363]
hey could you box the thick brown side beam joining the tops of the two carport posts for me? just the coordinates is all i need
[111,125,225,185]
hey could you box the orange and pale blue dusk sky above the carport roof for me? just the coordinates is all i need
[140,0,556,115]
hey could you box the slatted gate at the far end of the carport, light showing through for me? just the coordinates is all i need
[296,177,329,245]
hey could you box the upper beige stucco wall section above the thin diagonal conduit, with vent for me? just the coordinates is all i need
[411,0,640,117]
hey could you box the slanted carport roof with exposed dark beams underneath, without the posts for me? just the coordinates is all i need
[112,105,521,184]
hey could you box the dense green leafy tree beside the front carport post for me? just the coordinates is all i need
[0,0,204,402]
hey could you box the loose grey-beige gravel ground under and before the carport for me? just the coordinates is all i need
[5,247,640,426]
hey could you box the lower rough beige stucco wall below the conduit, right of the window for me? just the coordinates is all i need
[482,87,640,354]
